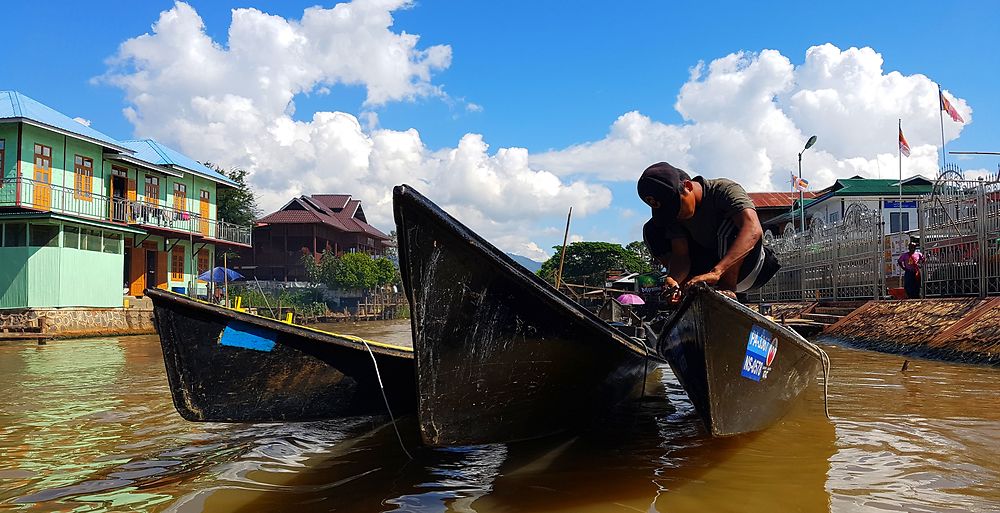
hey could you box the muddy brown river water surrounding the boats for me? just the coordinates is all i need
[0,322,1000,513]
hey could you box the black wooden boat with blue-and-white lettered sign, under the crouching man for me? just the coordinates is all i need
[649,286,828,436]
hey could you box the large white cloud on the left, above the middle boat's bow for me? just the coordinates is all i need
[102,0,611,258]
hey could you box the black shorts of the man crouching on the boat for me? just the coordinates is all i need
[643,219,781,292]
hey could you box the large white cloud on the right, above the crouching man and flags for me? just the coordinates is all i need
[529,44,971,190]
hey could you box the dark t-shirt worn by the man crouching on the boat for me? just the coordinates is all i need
[665,176,754,250]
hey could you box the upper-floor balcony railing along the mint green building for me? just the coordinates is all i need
[0,178,250,246]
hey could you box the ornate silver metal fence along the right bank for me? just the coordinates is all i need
[748,170,1000,302]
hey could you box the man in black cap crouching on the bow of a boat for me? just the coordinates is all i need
[636,162,781,301]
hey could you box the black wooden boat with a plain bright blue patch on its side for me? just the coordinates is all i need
[146,289,416,422]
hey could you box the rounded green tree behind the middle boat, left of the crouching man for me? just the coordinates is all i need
[538,242,650,284]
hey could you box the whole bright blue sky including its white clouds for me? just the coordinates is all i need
[0,0,1000,259]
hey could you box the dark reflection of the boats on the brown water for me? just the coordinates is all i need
[160,368,836,513]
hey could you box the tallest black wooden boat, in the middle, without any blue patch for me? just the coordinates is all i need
[393,185,655,445]
